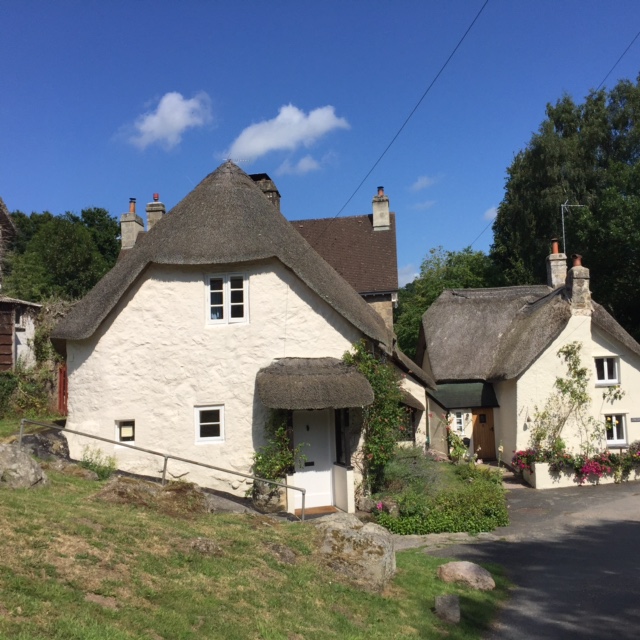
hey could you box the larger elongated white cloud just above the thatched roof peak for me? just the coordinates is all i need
[226,104,349,161]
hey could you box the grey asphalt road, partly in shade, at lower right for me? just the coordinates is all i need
[426,483,640,640]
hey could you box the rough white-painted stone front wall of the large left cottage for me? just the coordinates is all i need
[67,260,362,494]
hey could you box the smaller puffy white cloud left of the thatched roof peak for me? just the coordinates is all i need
[129,91,212,149]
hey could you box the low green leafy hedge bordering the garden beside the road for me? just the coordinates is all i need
[376,479,509,535]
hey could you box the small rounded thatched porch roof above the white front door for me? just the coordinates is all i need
[256,358,373,410]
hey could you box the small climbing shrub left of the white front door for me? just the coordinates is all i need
[253,411,306,480]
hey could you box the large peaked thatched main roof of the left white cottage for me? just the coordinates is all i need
[52,162,393,351]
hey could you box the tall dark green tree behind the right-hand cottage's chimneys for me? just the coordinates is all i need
[490,77,640,338]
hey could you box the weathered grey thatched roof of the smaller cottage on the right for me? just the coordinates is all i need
[422,285,640,384]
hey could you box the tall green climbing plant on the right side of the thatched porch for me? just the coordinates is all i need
[343,341,405,493]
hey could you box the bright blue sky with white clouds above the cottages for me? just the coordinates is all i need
[0,0,640,282]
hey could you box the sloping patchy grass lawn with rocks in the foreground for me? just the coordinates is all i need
[0,464,507,640]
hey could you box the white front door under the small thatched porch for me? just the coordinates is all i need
[293,409,333,509]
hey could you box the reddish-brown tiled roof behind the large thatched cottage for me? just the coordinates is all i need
[291,213,398,295]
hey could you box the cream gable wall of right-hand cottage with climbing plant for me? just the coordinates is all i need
[512,316,640,451]
